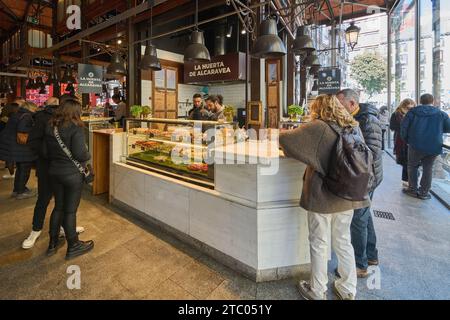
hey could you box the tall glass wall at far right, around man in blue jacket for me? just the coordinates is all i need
[390,0,450,202]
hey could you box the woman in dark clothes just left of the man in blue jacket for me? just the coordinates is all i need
[389,99,416,187]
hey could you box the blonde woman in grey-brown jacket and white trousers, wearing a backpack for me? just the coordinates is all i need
[280,95,370,300]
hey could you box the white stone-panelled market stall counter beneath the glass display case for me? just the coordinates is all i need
[110,120,309,282]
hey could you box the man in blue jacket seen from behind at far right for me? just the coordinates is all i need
[400,94,450,200]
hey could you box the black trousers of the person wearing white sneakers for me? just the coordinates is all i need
[33,159,53,231]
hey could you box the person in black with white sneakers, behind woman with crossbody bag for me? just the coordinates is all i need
[22,97,84,249]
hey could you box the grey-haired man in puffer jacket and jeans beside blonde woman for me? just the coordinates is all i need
[337,89,383,278]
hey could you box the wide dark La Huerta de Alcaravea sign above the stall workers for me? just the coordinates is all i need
[184,52,245,83]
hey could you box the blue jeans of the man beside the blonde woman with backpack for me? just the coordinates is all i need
[350,191,378,270]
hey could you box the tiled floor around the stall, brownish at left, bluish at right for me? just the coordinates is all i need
[0,156,450,299]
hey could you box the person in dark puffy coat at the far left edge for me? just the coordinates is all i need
[0,102,37,200]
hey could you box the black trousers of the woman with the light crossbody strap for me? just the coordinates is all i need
[50,173,83,241]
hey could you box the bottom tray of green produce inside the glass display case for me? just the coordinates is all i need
[127,150,214,189]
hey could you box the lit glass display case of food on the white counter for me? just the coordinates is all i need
[126,118,237,188]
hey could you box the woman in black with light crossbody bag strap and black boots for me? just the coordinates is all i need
[44,99,94,259]
